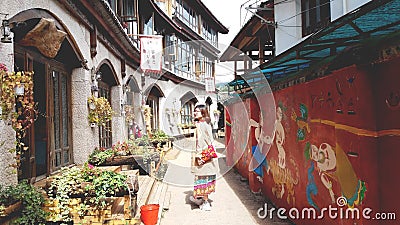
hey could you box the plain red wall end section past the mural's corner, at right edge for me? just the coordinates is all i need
[373,58,400,224]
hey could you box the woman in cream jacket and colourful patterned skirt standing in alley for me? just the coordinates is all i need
[190,104,218,211]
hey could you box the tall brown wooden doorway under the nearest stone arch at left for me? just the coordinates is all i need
[15,46,73,181]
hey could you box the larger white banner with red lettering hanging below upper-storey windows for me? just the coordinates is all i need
[140,35,162,72]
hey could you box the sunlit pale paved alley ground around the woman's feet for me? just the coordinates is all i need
[161,140,291,225]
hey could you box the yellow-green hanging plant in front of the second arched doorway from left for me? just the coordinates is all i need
[88,95,114,126]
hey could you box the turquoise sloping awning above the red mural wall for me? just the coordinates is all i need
[229,0,400,92]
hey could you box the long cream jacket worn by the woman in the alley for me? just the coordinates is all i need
[192,121,219,176]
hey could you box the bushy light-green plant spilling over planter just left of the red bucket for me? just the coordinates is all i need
[48,163,128,222]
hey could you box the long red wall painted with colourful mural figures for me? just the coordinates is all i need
[228,58,400,225]
